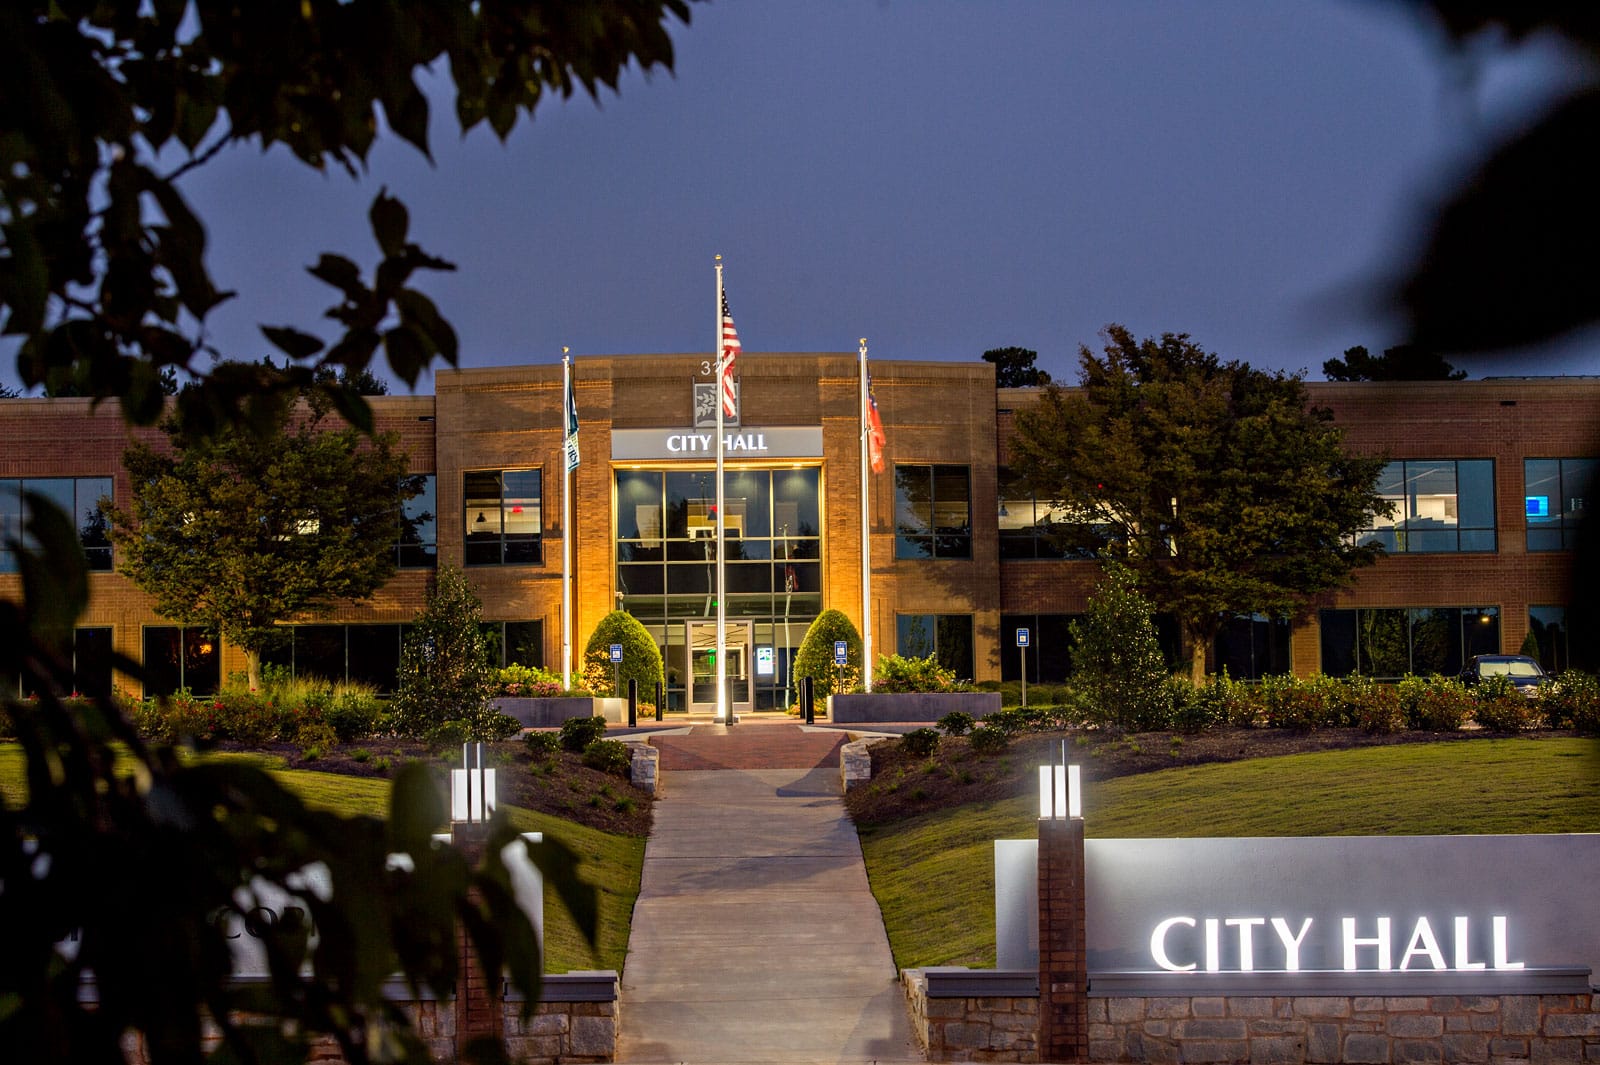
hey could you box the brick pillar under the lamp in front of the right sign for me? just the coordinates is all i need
[1038,819,1090,1062]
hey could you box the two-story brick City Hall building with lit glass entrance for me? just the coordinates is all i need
[0,353,1600,712]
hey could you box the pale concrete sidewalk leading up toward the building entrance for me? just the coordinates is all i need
[616,754,922,1065]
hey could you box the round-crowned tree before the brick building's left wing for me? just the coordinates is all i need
[110,393,419,688]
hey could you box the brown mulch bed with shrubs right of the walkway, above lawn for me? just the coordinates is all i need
[845,728,1570,825]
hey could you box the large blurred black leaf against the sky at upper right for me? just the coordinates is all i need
[1398,90,1600,352]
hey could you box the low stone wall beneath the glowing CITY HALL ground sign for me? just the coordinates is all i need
[902,969,1600,1065]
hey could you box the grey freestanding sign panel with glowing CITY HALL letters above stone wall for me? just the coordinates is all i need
[995,833,1600,983]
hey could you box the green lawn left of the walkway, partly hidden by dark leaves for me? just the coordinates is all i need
[0,744,645,972]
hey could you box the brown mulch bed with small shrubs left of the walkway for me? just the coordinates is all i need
[216,739,654,836]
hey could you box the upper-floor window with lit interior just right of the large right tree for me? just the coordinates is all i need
[1360,459,1496,553]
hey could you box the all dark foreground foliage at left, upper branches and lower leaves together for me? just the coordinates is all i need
[0,0,688,1063]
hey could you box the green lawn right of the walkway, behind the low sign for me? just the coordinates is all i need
[861,737,1600,967]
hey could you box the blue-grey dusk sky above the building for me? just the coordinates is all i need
[3,0,1600,390]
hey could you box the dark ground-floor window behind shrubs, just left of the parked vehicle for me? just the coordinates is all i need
[1320,606,1501,680]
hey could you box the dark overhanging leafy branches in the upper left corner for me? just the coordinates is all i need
[0,0,690,434]
